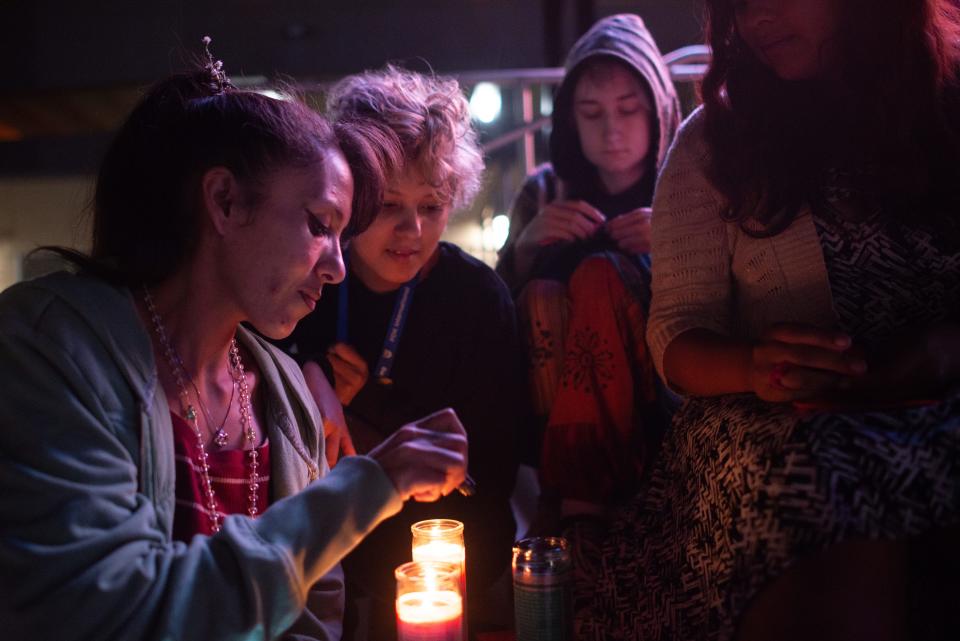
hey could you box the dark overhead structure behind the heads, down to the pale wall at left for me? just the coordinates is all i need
[0,0,700,176]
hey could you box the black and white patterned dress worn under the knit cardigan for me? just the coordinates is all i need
[573,208,960,641]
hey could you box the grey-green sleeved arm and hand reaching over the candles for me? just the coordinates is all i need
[0,294,466,641]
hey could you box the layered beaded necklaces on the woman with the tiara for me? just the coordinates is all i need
[143,286,260,533]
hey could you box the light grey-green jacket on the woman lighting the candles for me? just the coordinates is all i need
[0,273,401,641]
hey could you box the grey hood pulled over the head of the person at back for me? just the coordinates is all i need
[550,13,680,192]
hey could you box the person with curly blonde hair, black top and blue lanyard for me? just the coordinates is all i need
[286,66,525,639]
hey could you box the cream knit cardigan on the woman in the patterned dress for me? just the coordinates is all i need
[647,107,838,380]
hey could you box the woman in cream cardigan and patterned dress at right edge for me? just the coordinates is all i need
[578,0,960,639]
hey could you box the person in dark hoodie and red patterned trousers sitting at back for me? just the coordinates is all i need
[497,14,680,524]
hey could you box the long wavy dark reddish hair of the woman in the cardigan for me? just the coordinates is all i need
[701,0,960,236]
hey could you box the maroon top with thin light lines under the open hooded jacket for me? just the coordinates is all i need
[170,412,270,542]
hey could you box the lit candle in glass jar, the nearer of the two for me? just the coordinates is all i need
[394,561,464,641]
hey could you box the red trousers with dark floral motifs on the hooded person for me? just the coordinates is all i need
[521,252,664,504]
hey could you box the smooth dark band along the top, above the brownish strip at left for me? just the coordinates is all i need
[0,0,700,91]
